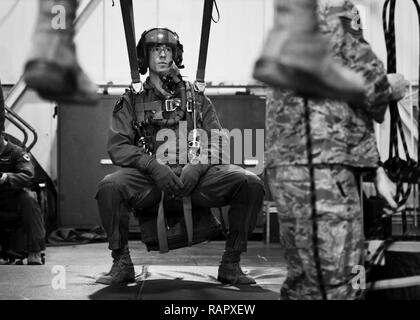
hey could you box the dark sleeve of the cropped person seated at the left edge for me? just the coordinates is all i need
[5,150,35,190]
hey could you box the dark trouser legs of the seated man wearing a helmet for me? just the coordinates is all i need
[96,165,265,252]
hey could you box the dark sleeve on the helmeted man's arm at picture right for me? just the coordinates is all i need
[202,96,230,164]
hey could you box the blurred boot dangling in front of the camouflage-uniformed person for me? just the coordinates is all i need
[253,0,365,102]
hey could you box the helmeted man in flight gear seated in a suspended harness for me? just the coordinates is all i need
[96,28,265,284]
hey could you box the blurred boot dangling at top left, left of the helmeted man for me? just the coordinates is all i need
[23,0,98,104]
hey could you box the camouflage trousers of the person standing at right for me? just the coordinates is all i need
[267,166,363,300]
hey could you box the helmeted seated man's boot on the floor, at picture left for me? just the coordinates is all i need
[96,247,135,285]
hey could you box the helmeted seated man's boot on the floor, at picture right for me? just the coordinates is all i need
[217,250,256,285]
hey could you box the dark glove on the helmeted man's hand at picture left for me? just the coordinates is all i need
[146,159,184,195]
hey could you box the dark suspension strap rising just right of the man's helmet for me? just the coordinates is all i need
[195,0,215,92]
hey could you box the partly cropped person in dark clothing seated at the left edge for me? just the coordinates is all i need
[0,83,45,265]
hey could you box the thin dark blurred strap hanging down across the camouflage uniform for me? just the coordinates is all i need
[304,98,327,300]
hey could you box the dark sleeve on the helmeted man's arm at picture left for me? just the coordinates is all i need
[107,95,151,170]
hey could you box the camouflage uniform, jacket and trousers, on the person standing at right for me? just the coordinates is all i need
[266,0,391,299]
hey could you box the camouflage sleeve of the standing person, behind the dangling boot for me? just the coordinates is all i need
[320,0,392,123]
